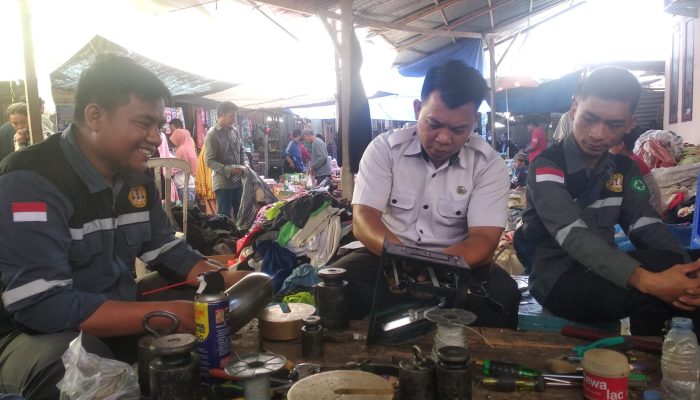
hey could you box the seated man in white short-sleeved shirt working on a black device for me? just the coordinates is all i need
[333,61,520,328]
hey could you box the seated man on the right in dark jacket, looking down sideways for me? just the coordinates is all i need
[523,68,700,335]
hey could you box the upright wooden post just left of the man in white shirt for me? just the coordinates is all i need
[340,0,355,200]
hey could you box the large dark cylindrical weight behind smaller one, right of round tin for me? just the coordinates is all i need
[316,268,349,330]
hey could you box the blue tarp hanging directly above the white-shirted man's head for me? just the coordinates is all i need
[399,38,484,77]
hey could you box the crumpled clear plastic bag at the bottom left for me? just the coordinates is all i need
[56,332,140,400]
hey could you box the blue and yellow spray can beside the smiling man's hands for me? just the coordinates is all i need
[194,271,231,386]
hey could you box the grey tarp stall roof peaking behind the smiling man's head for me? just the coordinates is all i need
[51,35,235,97]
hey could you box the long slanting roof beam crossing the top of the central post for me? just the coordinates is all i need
[250,0,482,38]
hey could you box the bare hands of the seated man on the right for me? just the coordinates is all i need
[629,260,700,311]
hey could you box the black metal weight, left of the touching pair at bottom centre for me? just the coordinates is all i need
[399,346,435,400]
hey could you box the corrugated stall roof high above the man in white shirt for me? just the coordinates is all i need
[234,0,585,67]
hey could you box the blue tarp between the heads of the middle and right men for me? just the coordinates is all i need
[487,71,582,114]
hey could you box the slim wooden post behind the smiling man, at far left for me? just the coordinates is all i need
[19,0,44,144]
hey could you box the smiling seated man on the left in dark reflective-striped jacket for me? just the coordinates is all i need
[0,56,243,399]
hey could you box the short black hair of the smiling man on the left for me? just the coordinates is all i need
[73,53,171,122]
